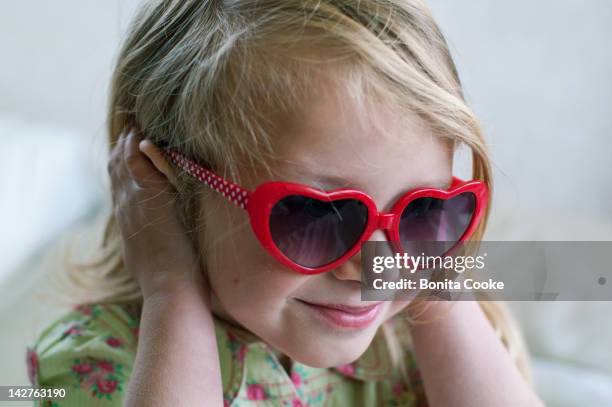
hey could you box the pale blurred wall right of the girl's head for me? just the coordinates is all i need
[430,0,612,220]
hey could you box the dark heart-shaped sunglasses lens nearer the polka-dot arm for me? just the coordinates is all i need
[270,195,368,267]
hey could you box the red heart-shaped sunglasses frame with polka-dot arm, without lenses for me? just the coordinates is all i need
[164,149,489,274]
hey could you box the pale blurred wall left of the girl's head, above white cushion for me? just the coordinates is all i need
[0,0,137,139]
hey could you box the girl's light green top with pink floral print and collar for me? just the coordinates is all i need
[27,305,427,407]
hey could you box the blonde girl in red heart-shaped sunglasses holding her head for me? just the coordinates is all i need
[28,0,541,406]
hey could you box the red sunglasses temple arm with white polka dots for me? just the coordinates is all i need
[163,150,251,209]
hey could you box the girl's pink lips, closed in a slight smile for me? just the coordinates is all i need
[298,300,382,329]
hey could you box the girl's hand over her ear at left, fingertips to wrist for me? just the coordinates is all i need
[108,132,205,299]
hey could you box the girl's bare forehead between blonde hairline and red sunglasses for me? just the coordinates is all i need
[246,70,452,189]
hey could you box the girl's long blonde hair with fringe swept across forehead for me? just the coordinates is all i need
[71,0,528,386]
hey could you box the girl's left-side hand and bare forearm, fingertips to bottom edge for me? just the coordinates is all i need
[108,133,223,407]
